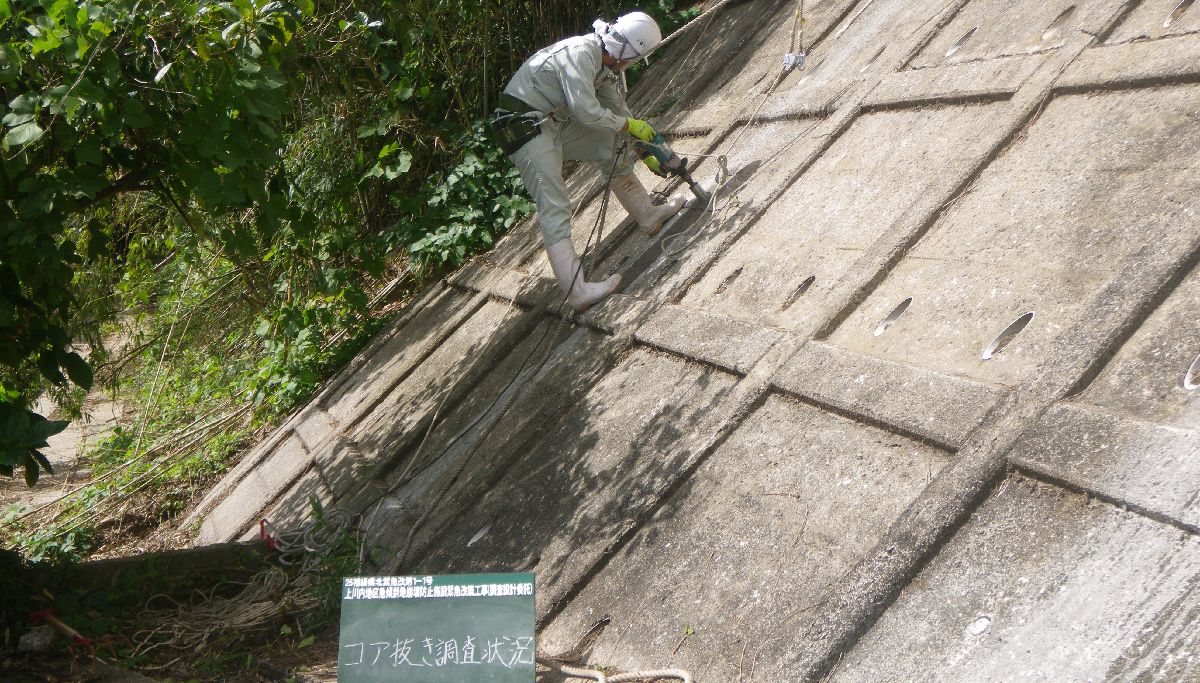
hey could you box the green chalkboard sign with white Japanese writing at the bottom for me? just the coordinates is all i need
[337,574,535,683]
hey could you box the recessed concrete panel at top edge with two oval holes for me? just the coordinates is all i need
[911,0,1124,68]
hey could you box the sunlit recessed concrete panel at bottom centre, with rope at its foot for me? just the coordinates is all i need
[539,396,948,681]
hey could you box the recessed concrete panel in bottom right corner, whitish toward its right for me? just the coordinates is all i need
[833,477,1200,682]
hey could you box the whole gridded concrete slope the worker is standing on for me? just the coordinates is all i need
[187,0,1200,682]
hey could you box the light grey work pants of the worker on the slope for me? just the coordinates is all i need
[509,120,635,246]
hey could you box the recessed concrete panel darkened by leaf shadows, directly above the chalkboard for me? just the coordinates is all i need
[416,351,733,615]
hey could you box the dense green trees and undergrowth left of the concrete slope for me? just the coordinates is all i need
[0,0,695,559]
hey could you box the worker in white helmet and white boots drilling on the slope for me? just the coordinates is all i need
[492,12,684,312]
